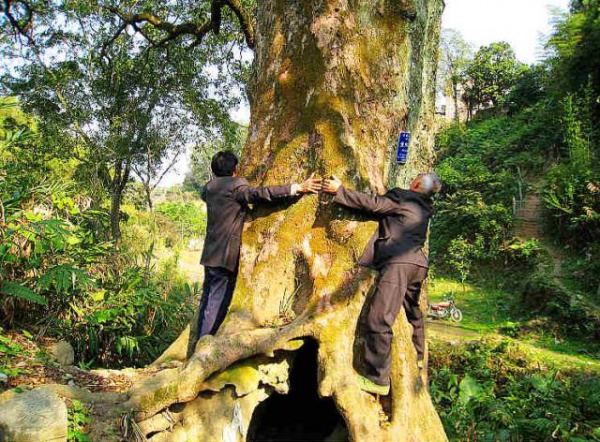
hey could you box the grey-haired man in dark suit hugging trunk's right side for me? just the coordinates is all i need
[323,173,441,395]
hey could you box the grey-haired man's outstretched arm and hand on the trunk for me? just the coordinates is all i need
[323,176,401,216]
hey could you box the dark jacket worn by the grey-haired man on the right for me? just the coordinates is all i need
[334,186,433,268]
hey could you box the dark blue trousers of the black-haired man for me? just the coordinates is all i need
[197,267,237,338]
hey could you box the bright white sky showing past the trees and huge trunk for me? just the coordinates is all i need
[161,0,569,187]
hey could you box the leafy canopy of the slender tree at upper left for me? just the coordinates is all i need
[2,2,251,241]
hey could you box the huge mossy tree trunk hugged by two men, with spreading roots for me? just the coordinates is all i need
[127,0,446,442]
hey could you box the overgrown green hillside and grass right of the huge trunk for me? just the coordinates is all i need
[430,1,600,441]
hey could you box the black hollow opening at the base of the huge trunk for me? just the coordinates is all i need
[247,339,348,442]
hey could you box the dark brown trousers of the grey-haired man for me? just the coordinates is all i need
[362,263,427,385]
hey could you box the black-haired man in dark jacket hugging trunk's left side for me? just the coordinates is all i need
[197,151,321,338]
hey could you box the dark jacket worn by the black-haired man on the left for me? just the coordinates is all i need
[200,176,292,272]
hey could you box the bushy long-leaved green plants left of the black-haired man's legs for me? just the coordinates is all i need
[65,267,192,366]
